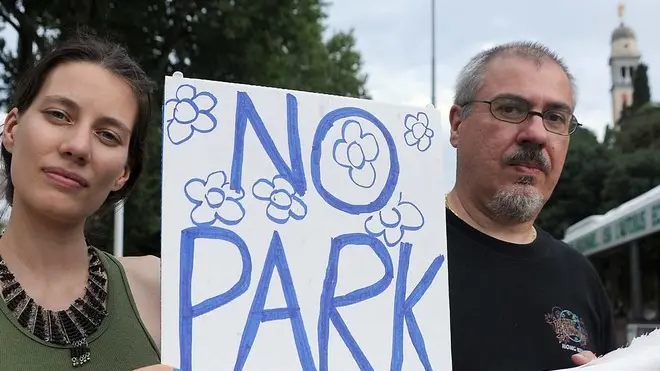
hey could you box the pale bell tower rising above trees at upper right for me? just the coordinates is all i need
[609,1,641,125]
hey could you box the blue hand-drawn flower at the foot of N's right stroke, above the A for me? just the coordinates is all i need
[252,175,307,224]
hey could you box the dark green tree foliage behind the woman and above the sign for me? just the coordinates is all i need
[0,0,368,254]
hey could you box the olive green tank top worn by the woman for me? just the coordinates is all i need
[0,250,160,371]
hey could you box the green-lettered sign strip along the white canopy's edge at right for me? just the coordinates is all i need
[569,201,660,255]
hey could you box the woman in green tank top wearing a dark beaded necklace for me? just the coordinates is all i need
[0,35,171,371]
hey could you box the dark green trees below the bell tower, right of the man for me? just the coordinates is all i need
[539,109,660,238]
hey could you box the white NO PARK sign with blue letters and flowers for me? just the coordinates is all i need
[162,75,451,371]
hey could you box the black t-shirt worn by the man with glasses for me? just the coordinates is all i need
[447,210,616,371]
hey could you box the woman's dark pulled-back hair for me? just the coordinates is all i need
[0,31,154,207]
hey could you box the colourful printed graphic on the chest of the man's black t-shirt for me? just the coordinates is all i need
[545,307,589,352]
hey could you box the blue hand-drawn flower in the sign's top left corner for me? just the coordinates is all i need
[163,84,218,144]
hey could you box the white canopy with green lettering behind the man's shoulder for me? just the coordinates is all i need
[564,186,660,255]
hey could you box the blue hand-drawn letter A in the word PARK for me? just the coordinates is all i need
[234,231,316,371]
